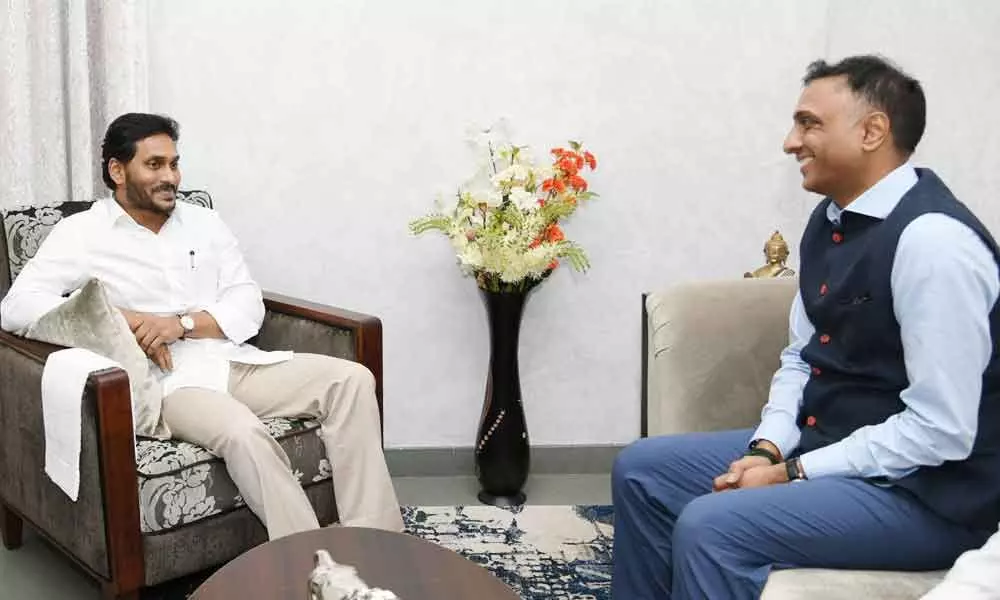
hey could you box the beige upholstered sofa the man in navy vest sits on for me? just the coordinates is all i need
[642,278,945,600]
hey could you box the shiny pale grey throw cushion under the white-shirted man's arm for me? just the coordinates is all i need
[24,279,163,435]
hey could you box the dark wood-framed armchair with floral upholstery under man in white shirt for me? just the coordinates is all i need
[0,192,382,600]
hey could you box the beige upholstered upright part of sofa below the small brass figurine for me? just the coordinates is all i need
[642,278,798,435]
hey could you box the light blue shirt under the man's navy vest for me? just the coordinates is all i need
[752,164,1000,479]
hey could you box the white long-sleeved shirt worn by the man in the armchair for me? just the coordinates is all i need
[0,197,291,396]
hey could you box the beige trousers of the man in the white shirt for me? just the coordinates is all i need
[161,353,403,540]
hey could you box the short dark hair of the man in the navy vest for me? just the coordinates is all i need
[802,55,927,155]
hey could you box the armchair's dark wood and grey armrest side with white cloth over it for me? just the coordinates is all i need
[0,331,143,585]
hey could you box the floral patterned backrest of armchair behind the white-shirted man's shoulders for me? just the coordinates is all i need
[0,190,212,281]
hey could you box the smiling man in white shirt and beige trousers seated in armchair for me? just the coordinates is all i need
[0,113,403,539]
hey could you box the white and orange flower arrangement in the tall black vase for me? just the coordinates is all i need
[410,130,597,292]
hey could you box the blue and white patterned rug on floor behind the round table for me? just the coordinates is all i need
[403,505,613,600]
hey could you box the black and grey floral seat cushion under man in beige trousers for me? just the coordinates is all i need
[136,418,332,534]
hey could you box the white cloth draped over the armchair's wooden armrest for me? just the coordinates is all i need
[42,348,120,502]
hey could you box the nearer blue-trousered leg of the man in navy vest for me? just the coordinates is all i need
[673,477,989,600]
